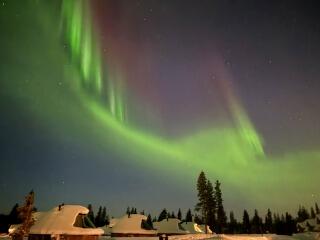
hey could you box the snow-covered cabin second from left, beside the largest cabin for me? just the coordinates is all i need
[105,214,157,237]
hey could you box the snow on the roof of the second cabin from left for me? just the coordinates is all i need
[111,214,157,234]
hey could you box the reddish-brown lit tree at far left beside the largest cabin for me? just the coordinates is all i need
[12,190,34,240]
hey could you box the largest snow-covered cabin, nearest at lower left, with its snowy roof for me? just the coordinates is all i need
[28,205,103,240]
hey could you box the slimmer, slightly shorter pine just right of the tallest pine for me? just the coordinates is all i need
[215,180,227,233]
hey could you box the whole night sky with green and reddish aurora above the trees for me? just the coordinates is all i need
[0,0,320,216]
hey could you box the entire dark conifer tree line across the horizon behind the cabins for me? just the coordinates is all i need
[0,179,320,235]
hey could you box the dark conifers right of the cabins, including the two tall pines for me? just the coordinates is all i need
[194,171,320,235]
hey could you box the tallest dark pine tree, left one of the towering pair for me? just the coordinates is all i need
[195,171,208,233]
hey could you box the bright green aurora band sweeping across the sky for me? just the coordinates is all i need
[1,0,320,214]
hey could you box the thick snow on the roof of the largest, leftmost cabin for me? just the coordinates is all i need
[30,205,103,235]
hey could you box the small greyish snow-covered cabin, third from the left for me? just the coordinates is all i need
[153,218,189,235]
